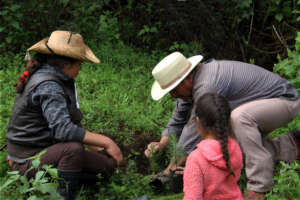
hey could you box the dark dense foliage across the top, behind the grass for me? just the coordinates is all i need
[0,0,300,67]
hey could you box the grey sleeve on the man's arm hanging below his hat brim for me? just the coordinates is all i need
[162,99,193,136]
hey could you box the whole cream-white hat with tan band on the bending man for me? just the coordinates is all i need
[151,52,203,100]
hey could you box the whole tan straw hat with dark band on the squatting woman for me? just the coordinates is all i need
[27,30,100,63]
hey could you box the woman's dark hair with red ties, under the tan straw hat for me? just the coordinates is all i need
[15,53,78,93]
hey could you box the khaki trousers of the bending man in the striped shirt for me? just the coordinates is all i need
[231,98,300,192]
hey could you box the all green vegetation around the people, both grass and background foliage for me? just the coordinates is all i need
[0,0,300,200]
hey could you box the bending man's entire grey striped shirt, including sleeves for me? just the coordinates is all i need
[162,61,299,152]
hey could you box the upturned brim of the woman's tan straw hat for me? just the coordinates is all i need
[27,37,100,63]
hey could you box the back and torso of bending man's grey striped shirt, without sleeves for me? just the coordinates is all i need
[193,61,298,109]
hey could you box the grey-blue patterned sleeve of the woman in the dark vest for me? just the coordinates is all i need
[31,81,85,142]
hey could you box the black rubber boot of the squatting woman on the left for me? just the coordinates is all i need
[57,170,81,200]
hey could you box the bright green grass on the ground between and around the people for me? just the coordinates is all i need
[0,43,300,200]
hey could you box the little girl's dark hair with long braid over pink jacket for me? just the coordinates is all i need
[196,93,234,175]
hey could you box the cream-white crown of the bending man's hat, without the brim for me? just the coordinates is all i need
[152,52,191,88]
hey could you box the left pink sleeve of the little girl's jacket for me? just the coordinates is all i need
[183,154,204,200]
